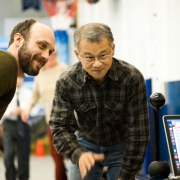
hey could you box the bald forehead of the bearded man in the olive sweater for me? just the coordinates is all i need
[29,23,55,49]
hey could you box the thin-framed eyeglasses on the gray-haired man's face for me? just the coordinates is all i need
[79,49,112,63]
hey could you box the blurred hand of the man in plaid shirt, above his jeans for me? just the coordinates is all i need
[79,152,104,179]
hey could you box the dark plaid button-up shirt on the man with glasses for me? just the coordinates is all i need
[50,58,149,180]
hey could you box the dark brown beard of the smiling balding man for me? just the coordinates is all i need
[18,43,41,76]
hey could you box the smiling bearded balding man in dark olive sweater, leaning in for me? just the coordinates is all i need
[0,19,55,119]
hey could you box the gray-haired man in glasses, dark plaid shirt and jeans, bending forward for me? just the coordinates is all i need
[50,23,149,180]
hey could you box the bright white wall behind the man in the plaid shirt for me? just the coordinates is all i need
[78,0,180,94]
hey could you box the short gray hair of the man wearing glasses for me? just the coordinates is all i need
[74,23,114,50]
